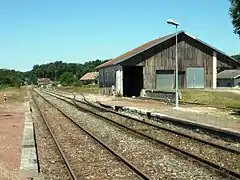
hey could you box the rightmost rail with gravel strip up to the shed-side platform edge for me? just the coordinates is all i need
[48,89,240,148]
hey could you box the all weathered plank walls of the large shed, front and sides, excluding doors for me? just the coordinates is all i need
[99,33,240,89]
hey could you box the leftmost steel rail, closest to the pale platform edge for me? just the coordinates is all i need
[31,93,78,180]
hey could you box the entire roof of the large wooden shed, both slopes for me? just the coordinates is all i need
[96,31,240,69]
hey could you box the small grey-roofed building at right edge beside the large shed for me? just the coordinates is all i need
[217,69,240,88]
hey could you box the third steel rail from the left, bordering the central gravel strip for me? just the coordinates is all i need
[46,92,240,179]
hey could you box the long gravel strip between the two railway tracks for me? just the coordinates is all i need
[40,91,229,179]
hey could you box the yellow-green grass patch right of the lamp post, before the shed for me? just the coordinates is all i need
[181,90,240,109]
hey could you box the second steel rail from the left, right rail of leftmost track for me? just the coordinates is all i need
[35,91,150,180]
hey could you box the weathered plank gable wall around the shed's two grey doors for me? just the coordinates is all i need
[141,35,225,89]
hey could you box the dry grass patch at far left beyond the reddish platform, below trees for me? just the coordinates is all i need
[0,86,27,104]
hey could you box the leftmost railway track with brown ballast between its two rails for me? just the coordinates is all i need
[31,90,150,179]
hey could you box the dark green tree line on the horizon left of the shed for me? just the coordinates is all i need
[0,59,108,88]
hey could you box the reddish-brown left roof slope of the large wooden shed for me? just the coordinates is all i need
[96,31,183,69]
